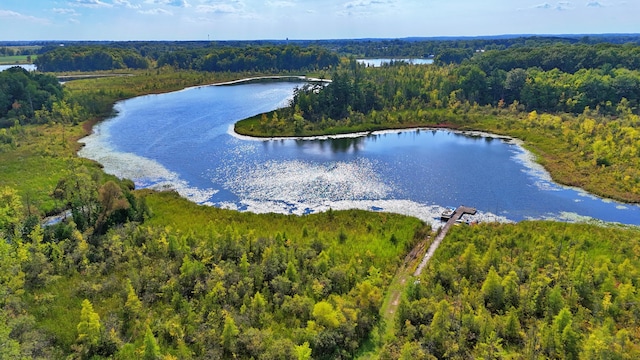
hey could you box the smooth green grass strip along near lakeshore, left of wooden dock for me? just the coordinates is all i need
[144,191,426,272]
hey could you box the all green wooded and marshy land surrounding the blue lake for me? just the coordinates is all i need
[0,36,640,359]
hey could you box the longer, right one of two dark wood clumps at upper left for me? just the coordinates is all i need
[158,46,339,72]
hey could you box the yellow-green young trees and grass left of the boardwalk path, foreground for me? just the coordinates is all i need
[0,164,428,359]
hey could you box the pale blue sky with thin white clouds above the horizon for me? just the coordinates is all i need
[0,0,640,40]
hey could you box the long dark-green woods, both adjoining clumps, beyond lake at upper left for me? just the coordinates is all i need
[35,44,338,73]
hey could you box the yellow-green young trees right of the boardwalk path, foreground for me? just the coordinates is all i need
[380,222,640,359]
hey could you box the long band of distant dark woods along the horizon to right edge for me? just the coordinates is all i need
[31,35,640,72]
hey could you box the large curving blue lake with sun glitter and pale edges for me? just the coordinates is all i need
[79,82,640,225]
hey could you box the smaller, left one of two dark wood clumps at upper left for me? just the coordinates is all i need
[35,46,149,71]
